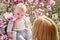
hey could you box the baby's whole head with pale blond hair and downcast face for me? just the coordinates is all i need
[13,3,26,19]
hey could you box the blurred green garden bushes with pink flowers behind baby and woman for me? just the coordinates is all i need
[0,0,60,39]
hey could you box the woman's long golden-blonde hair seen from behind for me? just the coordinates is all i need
[32,16,58,40]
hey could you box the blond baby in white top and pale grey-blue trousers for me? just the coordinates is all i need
[7,3,31,40]
